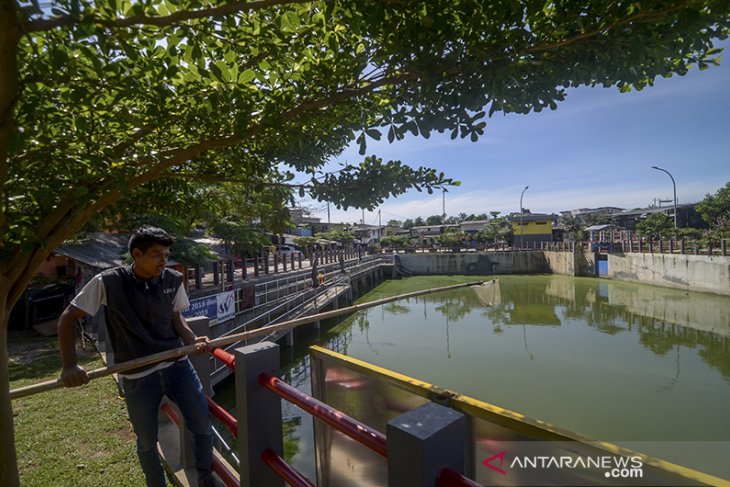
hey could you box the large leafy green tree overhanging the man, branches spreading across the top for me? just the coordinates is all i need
[0,0,730,486]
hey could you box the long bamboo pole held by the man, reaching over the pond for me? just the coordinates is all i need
[10,281,491,400]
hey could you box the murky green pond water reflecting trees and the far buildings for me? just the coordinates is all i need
[215,275,730,479]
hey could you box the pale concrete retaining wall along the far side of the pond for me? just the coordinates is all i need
[398,250,730,296]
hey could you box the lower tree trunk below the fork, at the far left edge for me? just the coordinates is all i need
[0,304,20,487]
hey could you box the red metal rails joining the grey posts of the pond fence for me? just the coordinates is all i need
[209,348,481,487]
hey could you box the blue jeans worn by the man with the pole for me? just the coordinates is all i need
[122,359,213,487]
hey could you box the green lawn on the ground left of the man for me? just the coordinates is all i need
[8,331,145,487]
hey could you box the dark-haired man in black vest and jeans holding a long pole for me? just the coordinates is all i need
[58,227,216,487]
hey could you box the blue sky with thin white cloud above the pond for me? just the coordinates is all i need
[298,41,730,225]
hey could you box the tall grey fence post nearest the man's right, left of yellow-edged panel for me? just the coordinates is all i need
[233,342,284,487]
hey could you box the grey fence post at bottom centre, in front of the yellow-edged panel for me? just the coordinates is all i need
[386,402,467,487]
